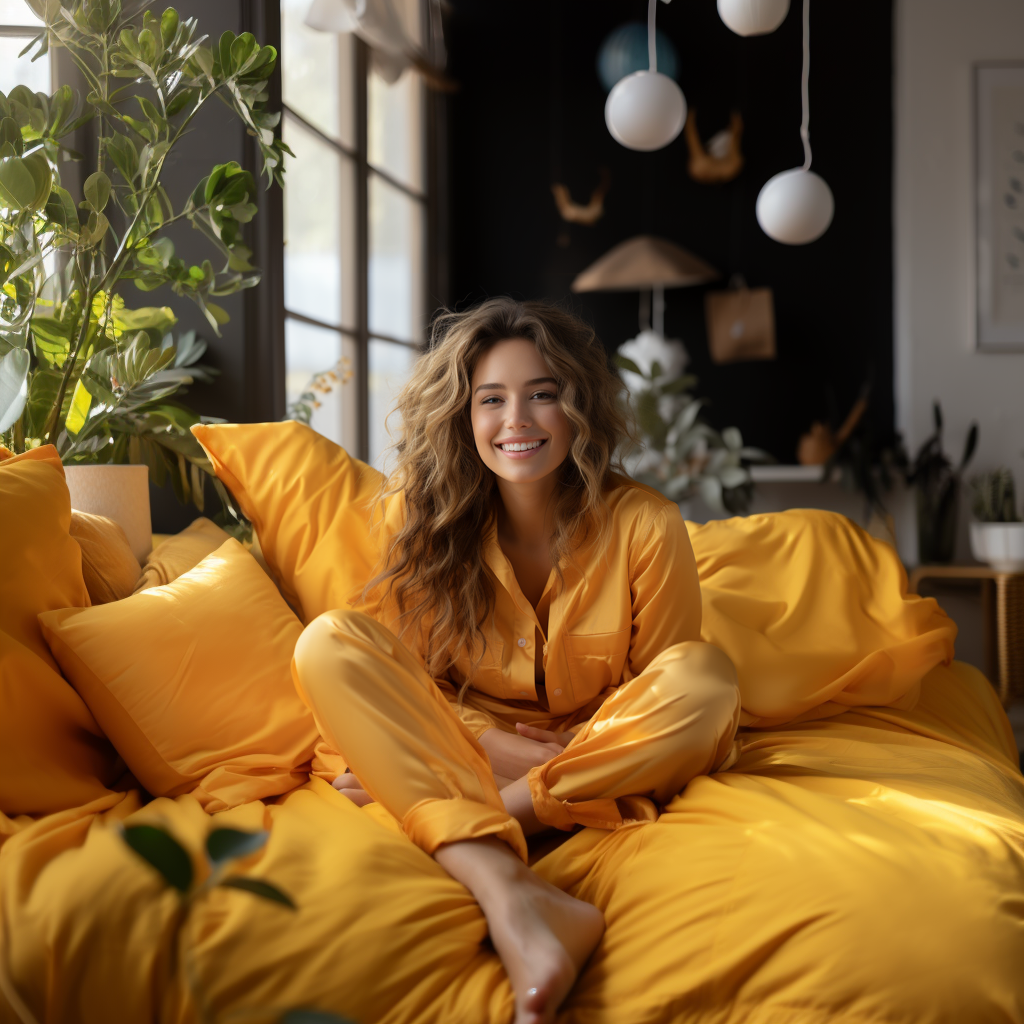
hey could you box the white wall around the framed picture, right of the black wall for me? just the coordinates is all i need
[892,0,1024,483]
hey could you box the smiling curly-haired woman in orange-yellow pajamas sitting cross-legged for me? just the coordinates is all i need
[294,299,739,1024]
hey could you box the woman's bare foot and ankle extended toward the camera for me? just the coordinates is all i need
[434,839,604,1024]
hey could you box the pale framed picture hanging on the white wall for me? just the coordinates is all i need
[974,61,1024,352]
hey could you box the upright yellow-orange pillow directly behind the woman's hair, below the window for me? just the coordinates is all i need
[191,421,383,623]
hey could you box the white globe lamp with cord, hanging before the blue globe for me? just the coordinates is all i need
[604,0,686,153]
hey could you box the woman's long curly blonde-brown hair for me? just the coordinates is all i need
[367,297,632,677]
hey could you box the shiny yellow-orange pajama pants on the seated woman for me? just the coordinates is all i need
[293,609,739,859]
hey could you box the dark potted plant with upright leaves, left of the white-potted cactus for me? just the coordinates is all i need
[906,402,978,565]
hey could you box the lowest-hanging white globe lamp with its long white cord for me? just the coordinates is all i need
[757,0,836,246]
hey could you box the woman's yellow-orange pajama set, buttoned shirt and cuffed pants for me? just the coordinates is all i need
[293,477,739,857]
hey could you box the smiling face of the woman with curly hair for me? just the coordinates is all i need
[470,338,572,483]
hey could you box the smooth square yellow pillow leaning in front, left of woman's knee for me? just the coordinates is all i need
[40,540,348,813]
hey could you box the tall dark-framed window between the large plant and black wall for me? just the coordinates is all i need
[282,0,428,467]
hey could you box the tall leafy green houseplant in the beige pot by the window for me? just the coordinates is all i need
[0,0,288,520]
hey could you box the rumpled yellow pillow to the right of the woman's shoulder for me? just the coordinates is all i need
[687,509,956,726]
